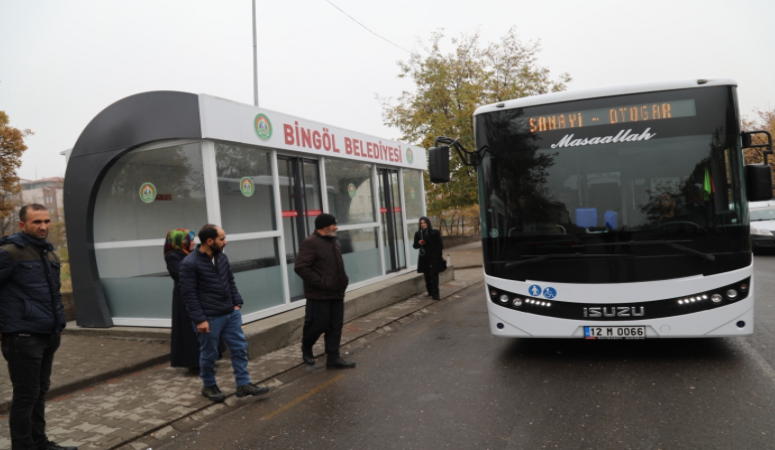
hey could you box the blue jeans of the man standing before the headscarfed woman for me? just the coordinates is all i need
[194,310,250,386]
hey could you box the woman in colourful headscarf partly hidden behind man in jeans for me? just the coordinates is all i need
[164,228,199,371]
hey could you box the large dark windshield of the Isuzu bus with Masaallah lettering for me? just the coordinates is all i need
[475,87,750,283]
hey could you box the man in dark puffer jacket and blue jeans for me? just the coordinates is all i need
[178,224,269,402]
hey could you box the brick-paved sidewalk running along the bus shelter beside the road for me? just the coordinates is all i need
[0,243,482,450]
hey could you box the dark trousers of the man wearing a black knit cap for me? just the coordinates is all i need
[301,299,344,358]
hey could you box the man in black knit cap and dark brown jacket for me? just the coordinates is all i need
[294,214,355,369]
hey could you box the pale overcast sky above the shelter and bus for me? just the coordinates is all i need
[0,0,775,179]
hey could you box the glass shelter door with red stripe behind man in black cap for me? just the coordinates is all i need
[277,155,323,301]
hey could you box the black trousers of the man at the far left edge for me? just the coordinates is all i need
[0,333,60,450]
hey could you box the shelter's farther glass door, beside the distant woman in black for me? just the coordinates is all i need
[378,169,406,273]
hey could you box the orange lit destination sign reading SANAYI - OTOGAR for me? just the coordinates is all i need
[527,100,697,133]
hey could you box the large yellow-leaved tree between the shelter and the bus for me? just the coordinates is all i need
[380,28,570,218]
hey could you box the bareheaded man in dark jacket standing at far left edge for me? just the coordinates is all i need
[0,204,77,450]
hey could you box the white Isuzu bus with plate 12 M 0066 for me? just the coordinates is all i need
[430,79,772,339]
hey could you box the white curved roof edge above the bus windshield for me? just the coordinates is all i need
[474,78,737,115]
